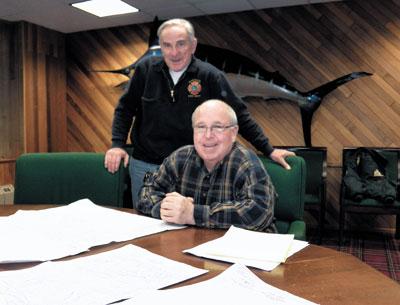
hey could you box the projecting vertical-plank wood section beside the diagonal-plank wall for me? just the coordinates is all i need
[20,22,67,152]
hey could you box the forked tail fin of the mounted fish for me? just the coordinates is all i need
[300,72,372,147]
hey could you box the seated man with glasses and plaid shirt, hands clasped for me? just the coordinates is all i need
[138,100,276,232]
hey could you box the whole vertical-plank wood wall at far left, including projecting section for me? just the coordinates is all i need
[0,21,67,184]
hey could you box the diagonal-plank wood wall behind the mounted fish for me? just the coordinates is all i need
[67,0,400,228]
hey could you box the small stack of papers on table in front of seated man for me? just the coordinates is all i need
[183,226,308,271]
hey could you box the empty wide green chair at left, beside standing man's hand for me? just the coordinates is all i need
[14,152,126,207]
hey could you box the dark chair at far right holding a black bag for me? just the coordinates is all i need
[339,147,400,245]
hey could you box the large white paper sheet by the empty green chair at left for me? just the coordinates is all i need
[0,199,183,263]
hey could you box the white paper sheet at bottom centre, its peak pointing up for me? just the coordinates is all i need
[120,264,316,305]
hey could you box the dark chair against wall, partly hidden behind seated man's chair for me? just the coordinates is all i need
[281,146,327,244]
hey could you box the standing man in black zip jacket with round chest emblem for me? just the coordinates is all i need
[104,19,294,208]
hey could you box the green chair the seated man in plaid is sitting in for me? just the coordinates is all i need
[260,156,306,240]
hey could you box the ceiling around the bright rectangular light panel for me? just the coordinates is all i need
[0,0,340,33]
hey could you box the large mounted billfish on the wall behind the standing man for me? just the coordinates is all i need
[94,20,372,147]
